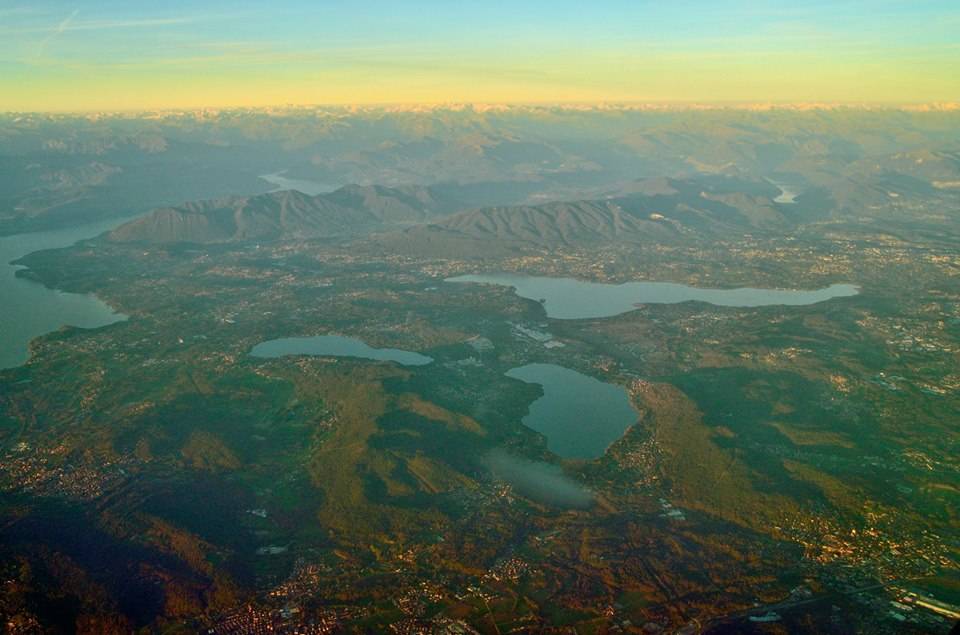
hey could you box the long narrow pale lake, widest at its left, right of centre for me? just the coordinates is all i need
[446,273,859,320]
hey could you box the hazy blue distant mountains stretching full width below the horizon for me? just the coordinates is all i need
[0,104,960,235]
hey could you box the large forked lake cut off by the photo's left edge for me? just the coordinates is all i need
[0,218,130,368]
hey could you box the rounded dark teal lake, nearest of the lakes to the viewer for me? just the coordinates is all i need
[507,364,637,459]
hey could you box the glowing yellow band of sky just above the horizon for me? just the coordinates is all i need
[7,53,960,112]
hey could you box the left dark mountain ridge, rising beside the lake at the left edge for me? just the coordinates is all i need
[108,185,460,244]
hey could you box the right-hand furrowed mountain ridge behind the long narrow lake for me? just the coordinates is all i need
[376,177,793,256]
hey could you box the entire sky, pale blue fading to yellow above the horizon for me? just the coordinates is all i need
[0,0,960,111]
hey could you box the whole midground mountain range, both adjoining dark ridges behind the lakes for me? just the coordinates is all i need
[109,176,810,255]
